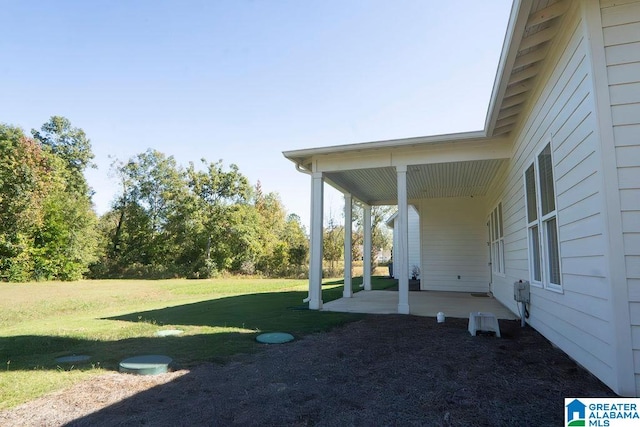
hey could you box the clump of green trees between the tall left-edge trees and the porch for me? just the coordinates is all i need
[91,150,309,278]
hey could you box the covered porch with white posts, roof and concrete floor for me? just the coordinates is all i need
[284,132,514,318]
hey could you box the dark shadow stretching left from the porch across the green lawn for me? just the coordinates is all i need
[0,288,362,371]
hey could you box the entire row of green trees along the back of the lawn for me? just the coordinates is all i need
[0,116,389,282]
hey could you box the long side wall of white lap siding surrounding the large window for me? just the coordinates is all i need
[487,2,616,392]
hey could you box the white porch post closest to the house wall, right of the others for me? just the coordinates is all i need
[394,166,409,314]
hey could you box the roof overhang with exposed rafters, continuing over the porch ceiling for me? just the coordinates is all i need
[283,0,570,205]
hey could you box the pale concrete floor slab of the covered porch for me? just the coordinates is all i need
[322,290,517,320]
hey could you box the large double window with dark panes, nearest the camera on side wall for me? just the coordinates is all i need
[524,143,562,290]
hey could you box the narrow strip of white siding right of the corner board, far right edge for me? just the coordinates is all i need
[600,0,640,393]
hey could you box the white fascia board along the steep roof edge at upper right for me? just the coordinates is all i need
[484,0,532,135]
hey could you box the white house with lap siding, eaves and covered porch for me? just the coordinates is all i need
[284,0,640,396]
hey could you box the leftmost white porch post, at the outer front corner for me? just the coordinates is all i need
[309,172,324,310]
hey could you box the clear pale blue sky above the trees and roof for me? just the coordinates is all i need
[0,0,511,229]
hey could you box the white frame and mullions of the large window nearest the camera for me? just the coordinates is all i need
[523,142,563,293]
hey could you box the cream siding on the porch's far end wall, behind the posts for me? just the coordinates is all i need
[419,197,489,292]
